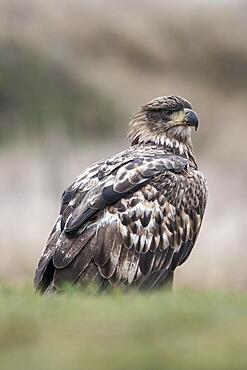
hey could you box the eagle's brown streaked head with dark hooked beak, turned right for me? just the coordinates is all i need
[128,95,199,146]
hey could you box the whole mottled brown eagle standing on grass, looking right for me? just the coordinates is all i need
[34,95,207,293]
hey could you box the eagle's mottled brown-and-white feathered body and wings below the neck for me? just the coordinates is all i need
[35,153,205,288]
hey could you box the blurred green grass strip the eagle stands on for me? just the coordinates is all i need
[0,286,247,370]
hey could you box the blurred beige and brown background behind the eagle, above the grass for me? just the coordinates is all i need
[0,0,247,289]
